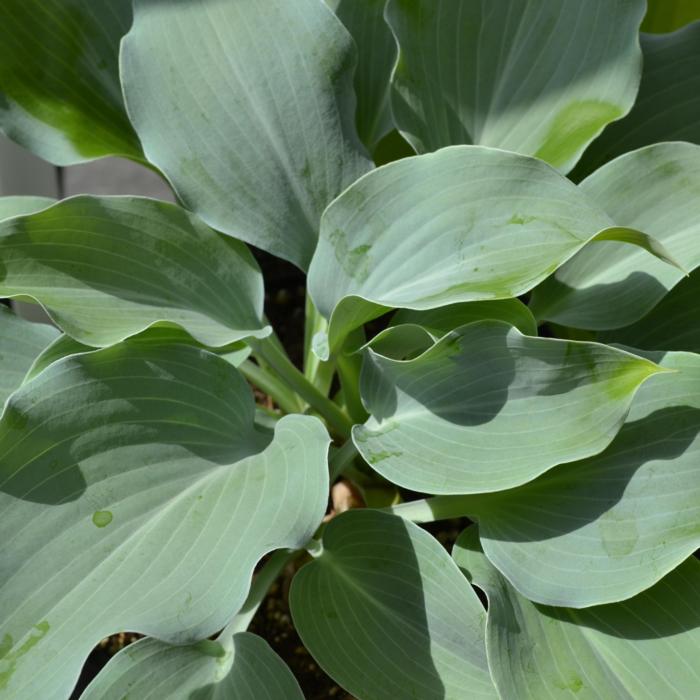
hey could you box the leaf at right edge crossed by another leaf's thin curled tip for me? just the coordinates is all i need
[530,143,700,330]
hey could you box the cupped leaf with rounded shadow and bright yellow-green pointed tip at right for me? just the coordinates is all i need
[352,321,659,494]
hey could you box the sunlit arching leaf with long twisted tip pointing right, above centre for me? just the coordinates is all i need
[309,146,680,357]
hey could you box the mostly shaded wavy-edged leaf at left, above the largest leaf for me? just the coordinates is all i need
[0,196,269,346]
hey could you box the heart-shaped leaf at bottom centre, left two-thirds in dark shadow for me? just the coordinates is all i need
[290,509,497,700]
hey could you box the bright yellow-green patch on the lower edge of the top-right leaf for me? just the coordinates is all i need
[535,100,622,167]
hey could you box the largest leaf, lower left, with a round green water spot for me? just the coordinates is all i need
[0,341,329,700]
